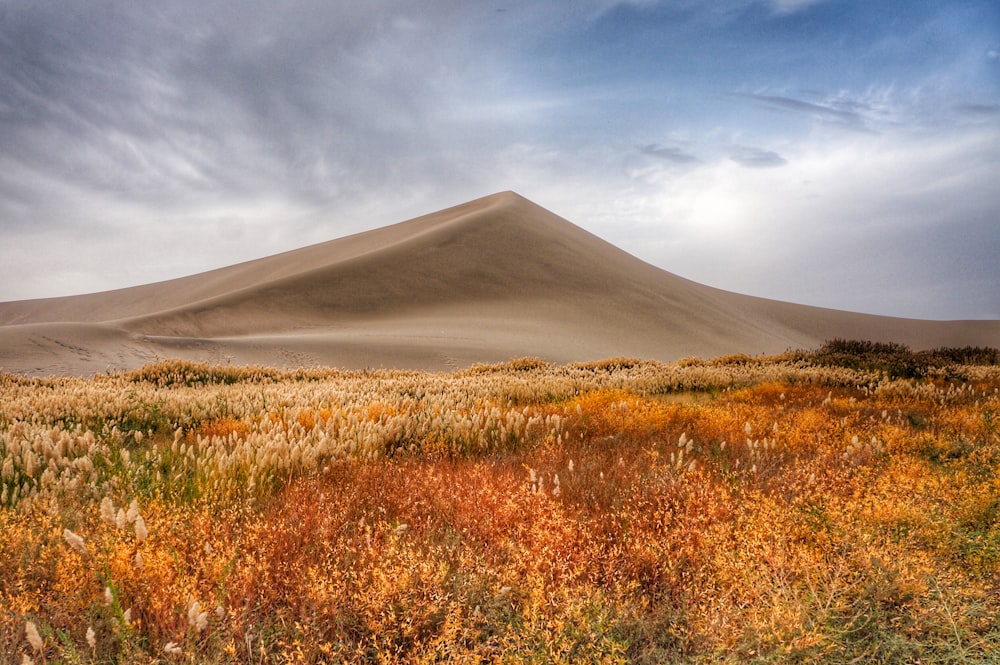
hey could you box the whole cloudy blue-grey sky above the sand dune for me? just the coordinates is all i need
[0,0,1000,319]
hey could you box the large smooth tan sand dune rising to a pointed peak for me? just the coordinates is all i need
[0,192,1000,376]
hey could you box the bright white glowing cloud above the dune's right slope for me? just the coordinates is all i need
[592,126,1000,318]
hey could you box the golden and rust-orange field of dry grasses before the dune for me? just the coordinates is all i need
[0,342,1000,663]
